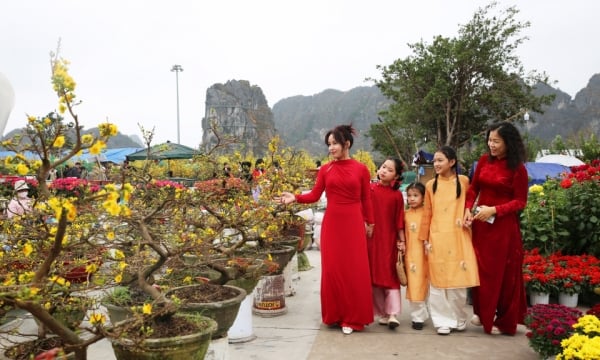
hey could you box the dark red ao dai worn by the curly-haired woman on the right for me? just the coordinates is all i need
[467,154,529,335]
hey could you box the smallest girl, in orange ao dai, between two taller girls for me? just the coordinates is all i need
[404,183,429,330]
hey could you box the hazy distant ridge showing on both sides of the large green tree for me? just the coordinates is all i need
[273,74,600,156]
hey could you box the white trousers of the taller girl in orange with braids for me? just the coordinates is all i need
[429,286,467,328]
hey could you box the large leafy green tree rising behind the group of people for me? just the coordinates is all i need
[370,2,553,151]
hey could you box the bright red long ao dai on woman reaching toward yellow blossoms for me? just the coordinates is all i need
[296,159,373,330]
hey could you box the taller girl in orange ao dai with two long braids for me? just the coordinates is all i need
[419,146,479,335]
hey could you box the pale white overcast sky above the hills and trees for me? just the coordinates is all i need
[0,0,600,147]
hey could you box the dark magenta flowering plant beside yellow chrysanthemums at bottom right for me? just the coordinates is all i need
[525,304,582,359]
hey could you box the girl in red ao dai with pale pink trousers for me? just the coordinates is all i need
[367,158,406,329]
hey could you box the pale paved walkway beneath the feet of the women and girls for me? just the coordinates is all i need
[0,250,538,360]
